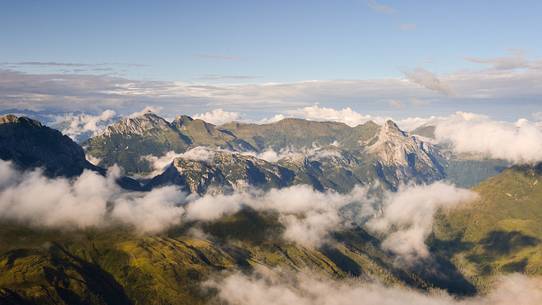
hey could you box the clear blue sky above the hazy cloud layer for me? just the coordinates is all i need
[0,0,542,117]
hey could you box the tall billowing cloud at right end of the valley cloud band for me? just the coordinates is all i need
[367,182,476,263]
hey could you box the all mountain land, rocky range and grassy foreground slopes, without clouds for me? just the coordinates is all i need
[0,113,542,304]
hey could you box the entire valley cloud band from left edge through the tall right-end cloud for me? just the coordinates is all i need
[0,161,476,256]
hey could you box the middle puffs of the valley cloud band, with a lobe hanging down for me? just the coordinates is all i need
[186,185,373,247]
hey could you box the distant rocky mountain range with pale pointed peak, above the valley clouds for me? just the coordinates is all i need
[82,112,505,193]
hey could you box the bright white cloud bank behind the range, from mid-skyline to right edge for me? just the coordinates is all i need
[272,105,542,164]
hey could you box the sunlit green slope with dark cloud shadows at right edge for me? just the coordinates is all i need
[433,168,542,288]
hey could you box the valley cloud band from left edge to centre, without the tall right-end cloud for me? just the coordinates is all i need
[0,161,372,246]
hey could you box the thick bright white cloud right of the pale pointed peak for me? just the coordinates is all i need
[435,112,542,164]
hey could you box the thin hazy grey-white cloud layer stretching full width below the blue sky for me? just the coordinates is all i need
[0,61,542,114]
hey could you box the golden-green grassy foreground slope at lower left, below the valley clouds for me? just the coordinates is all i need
[0,212,428,304]
